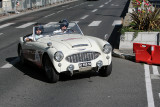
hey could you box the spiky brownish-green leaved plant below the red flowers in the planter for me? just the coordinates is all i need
[130,8,160,31]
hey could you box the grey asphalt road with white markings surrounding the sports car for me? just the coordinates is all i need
[0,0,160,107]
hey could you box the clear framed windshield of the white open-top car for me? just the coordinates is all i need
[33,22,83,36]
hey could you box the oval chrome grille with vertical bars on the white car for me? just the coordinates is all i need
[66,52,100,63]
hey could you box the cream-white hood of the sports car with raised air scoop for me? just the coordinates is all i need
[39,35,92,49]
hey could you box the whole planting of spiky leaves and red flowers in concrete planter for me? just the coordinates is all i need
[121,0,160,40]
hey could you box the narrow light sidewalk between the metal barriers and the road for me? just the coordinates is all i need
[0,0,77,22]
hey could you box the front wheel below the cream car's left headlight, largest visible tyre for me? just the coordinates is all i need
[44,56,59,83]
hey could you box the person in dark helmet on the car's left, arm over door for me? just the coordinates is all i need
[25,26,43,42]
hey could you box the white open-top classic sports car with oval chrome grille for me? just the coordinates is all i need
[18,23,112,83]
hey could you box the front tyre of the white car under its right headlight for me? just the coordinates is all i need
[99,62,112,77]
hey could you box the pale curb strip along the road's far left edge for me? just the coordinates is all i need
[0,0,78,22]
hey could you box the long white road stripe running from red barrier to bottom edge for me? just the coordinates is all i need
[144,64,155,107]
